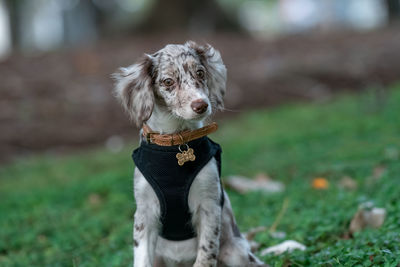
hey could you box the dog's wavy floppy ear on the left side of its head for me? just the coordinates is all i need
[112,55,156,127]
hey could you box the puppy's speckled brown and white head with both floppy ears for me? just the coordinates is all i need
[113,42,226,127]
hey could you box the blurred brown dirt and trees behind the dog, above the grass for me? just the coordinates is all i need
[0,0,400,163]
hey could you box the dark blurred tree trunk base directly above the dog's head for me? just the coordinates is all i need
[139,0,240,32]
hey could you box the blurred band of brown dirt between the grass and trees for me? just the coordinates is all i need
[0,27,400,162]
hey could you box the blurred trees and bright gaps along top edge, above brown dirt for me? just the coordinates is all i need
[0,0,400,55]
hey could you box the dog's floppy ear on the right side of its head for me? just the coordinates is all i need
[185,41,226,109]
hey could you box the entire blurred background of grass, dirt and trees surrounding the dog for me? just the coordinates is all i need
[0,0,400,267]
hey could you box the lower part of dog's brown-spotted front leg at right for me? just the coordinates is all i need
[193,199,221,267]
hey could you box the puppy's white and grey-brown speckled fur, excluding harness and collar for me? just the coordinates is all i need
[114,42,267,267]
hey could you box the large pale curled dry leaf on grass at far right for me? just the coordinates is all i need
[349,202,386,234]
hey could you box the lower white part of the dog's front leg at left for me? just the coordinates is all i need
[133,210,158,267]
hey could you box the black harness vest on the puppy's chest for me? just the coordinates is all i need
[132,136,224,241]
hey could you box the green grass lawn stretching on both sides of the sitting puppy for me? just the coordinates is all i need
[0,86,400,267]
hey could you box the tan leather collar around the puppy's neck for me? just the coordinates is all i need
[142,122,218,146]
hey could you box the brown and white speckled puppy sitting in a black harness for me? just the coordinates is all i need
[113,41,268,267]
